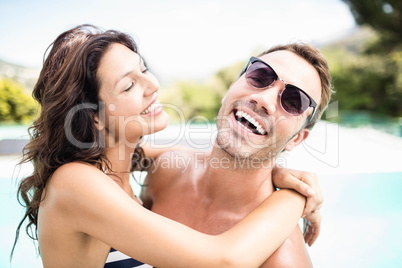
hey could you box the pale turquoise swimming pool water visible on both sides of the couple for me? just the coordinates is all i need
[0,159,402,268]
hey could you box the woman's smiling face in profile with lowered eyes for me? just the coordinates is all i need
[97,43,169,144]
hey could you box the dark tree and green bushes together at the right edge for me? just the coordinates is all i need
[326,0,402,117]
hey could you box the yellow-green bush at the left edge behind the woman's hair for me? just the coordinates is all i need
[0,79,38,123]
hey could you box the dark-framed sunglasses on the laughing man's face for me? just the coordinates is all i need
[239,57,317,122]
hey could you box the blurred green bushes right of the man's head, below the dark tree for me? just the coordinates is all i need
[323,37,402,116]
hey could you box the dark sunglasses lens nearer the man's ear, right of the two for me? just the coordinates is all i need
[281,85,310,115]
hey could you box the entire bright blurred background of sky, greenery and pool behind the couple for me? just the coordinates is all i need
[0,0,402,267]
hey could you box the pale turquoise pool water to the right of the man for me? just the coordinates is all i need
[309,172,402,268]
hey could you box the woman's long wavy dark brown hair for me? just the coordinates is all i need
[10,24,147,259]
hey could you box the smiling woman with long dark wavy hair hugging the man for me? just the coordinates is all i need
[13,25,318,267]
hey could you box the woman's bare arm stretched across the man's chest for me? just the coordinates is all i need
[46,163,305,267]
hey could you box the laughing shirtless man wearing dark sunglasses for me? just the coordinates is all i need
[142,44,331,267]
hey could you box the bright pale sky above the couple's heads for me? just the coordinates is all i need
[0,0,355,81]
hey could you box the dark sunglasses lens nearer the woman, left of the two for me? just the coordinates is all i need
[246,61,277,88]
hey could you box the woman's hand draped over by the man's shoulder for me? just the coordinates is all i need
[272,167,324,246]
